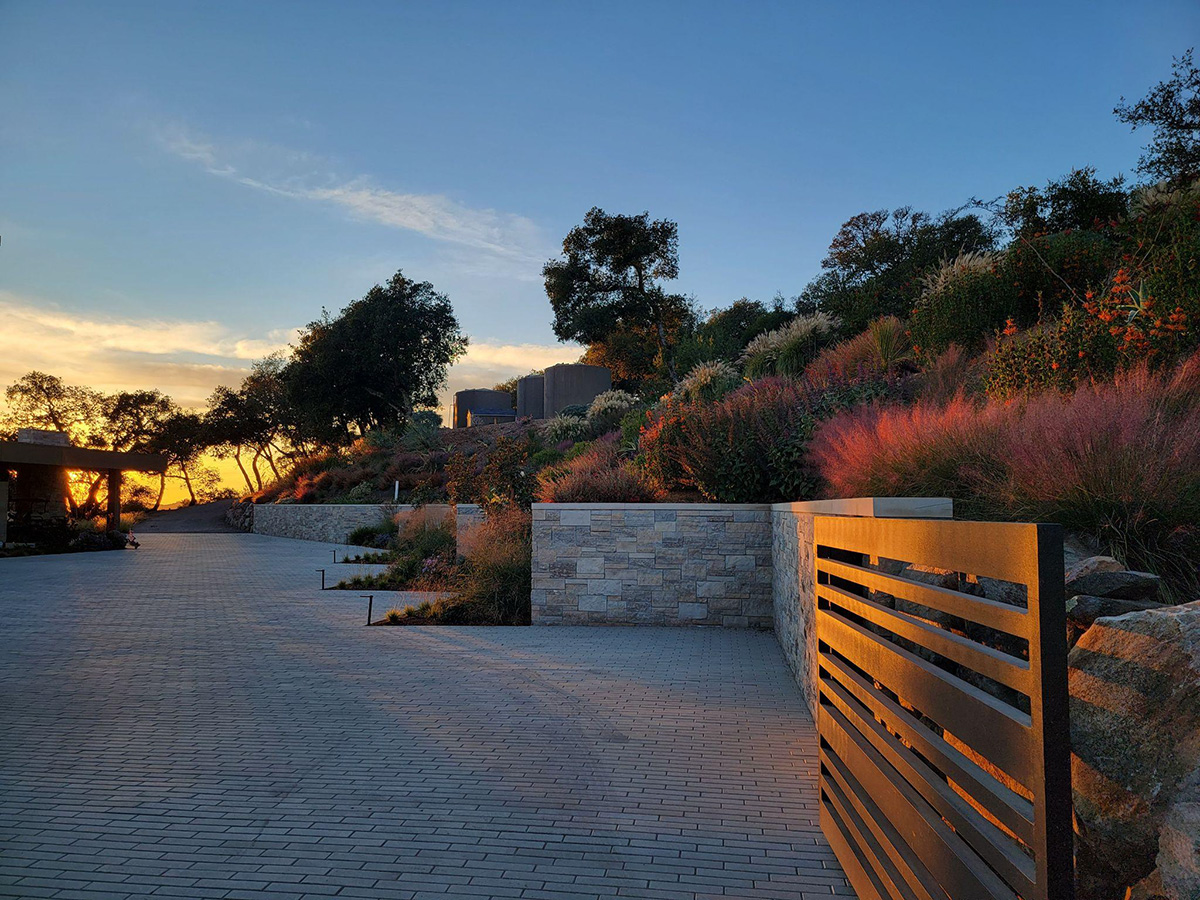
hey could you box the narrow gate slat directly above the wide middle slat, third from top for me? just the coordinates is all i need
[817,584,1032,696]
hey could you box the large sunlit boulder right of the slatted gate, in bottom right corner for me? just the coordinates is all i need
[1068,598,1200,900]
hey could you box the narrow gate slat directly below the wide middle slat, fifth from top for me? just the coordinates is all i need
[820,654,1033,845]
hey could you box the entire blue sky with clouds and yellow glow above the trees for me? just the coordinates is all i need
[0,0,1200,403]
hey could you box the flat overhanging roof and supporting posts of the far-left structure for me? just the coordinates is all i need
[0,440,167,544]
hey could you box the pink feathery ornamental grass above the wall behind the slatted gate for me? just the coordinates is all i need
[811,354,1200,596]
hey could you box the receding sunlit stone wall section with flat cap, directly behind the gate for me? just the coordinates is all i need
[770,497,954,718]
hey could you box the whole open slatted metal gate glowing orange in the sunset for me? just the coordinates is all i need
[814,516,1074,900]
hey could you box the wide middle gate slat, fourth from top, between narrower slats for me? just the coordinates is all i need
[817,610,1036,785]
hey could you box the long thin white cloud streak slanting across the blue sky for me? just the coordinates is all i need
[155,125,550,266]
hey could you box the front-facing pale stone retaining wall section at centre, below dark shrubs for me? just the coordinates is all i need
[533,503,772,628]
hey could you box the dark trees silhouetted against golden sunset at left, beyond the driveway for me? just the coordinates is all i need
[0,272,467,517]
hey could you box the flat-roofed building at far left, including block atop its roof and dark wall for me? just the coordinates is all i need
[0,428,167,544]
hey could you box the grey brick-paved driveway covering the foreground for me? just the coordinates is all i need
[0,534,848,900]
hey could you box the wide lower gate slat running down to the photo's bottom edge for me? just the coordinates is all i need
[818,706,1019,900]
